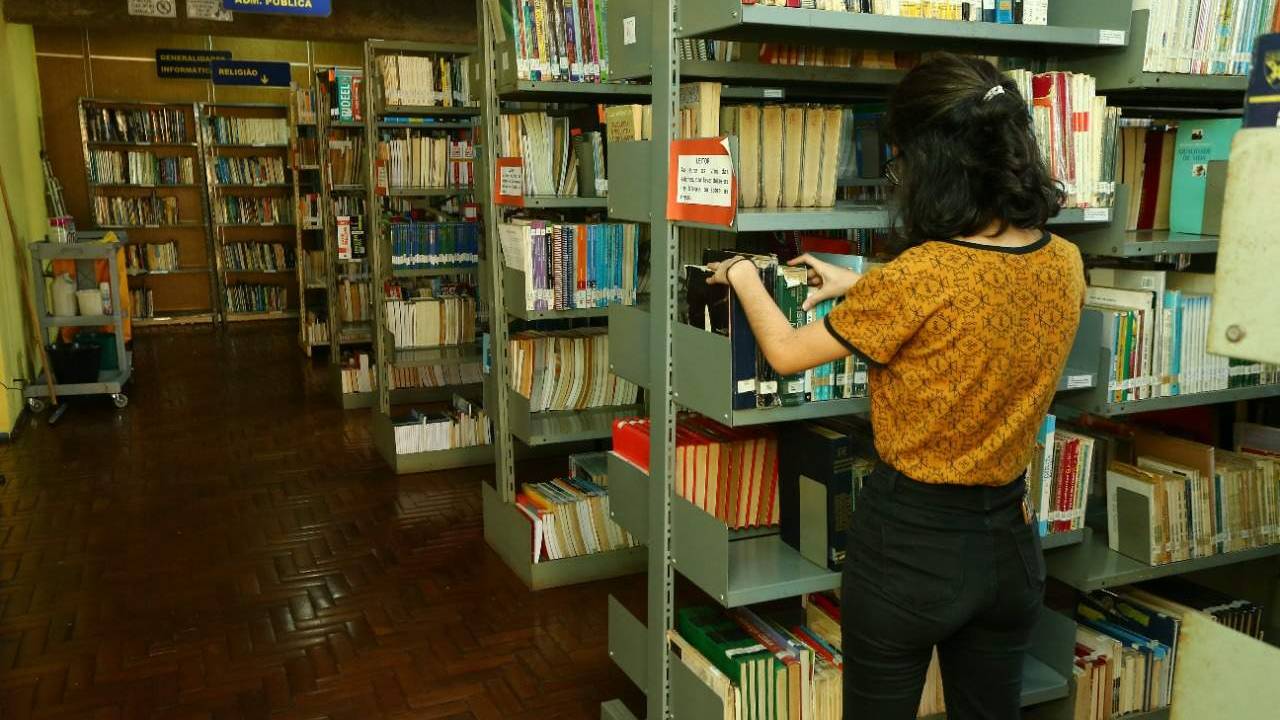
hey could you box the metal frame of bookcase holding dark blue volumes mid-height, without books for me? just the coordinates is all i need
[362,40,497,466]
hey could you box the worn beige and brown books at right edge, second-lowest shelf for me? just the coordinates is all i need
[1106,420,1280,565]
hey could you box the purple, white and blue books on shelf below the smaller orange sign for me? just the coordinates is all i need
[498,218,640,310]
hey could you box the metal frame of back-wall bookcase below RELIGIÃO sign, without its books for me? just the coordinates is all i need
[197,102,302,323]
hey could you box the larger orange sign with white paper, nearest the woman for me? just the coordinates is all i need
[667,137,737,227]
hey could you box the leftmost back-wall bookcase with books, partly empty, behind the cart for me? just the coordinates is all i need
[79,97,219,327]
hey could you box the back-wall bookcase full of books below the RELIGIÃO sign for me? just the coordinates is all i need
[200,102,300,323]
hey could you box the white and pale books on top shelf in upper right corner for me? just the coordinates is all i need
[1142,0,1280,76]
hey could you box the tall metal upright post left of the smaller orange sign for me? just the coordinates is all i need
[475,0,516,491]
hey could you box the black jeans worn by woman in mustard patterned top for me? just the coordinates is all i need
[841,462,1044,720]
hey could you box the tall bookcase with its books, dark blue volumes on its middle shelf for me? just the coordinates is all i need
[357,40,493,473]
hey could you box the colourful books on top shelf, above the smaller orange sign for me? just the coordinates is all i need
[499,0,609,82]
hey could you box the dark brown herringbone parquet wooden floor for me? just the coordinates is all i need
[0,324,644,720]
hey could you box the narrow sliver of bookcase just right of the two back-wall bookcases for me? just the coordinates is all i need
[289,87,332,357]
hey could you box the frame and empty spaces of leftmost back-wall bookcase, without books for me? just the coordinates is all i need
[77,97,221,328]
